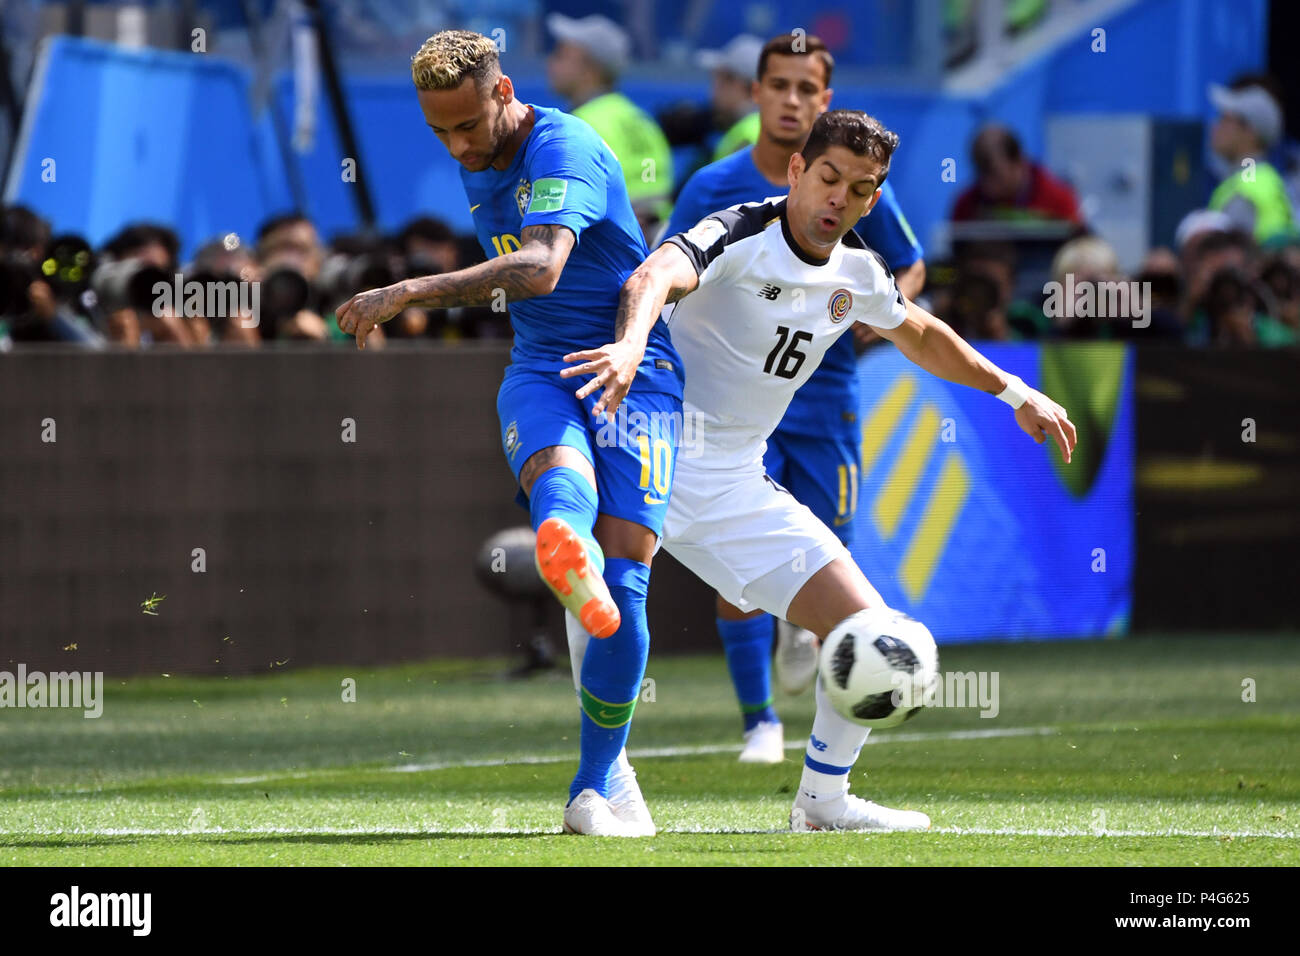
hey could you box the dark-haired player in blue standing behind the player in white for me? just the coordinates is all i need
[664,34,926,763]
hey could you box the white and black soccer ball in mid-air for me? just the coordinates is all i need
[818,607,939,727]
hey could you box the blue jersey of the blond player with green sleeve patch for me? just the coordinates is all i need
[460,107,686,398]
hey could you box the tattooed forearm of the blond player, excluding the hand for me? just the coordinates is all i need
[404,225,573,308]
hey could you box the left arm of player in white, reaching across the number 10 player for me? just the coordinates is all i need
[560,243,699,421]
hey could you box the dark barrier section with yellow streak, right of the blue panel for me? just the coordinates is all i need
[1132,349,1300,631]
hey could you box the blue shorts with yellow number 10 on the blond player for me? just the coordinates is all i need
[497,365,681,535]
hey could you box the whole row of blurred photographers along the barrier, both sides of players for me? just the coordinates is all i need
[0,187,1300,349]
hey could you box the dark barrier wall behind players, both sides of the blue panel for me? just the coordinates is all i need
[0,346,1300,674]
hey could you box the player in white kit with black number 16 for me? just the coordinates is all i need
[562,109,1075,830]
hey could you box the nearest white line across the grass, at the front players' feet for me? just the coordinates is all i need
[0,826,1300,840]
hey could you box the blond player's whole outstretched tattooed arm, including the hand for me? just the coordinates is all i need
[335,225,573,349]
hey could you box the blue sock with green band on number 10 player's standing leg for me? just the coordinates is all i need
[572,561,650,800]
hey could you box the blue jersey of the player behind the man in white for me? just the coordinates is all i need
[664,147,924,442]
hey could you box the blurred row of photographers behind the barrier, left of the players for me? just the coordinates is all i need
[0,206,511,349]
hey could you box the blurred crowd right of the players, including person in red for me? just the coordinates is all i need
[927,74,1300,347]
